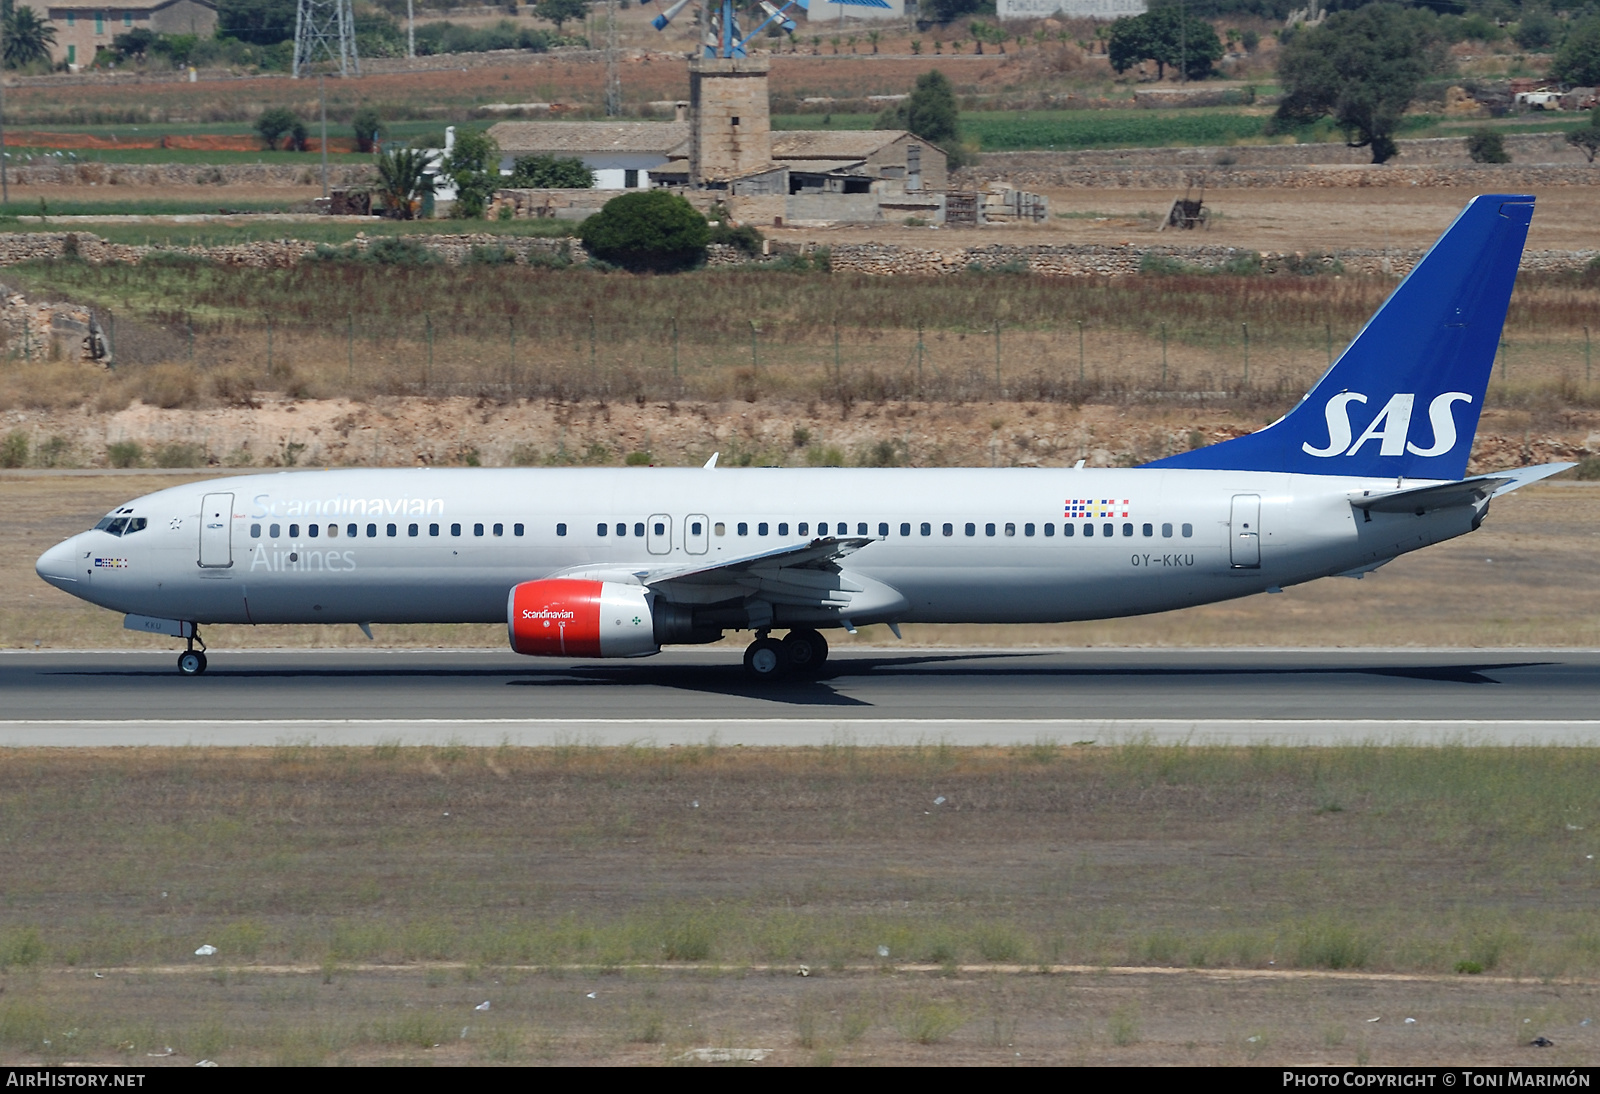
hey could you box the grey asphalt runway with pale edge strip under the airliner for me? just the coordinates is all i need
[0,649,1600,747]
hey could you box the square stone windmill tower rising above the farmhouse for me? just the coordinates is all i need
[690,58,773,186]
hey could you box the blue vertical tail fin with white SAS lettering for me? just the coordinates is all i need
[1147,194,1533,478]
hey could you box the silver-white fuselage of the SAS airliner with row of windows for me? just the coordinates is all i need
[38,469,1482,627]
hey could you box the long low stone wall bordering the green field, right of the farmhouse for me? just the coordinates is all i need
[950,159,1600,194]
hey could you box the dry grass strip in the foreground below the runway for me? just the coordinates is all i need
[0,742,1600,1064]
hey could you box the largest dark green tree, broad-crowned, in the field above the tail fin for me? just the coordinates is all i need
[1277,3,1446,163]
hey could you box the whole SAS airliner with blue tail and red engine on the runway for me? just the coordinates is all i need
[37,195,1570,678]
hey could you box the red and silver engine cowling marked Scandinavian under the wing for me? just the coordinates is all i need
[506,577,661,657]
